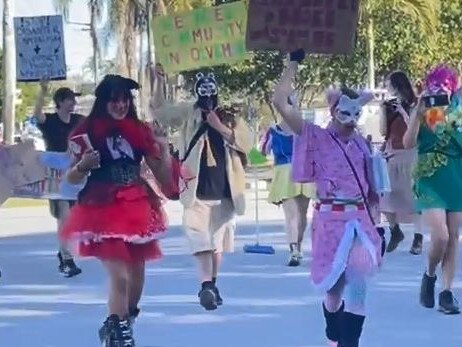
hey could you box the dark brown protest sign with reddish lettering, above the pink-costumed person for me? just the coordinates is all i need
[246,0,360,54]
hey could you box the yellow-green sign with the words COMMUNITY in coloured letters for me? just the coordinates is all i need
[153,2,247,72]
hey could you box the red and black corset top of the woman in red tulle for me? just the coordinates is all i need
[71,118,166,205]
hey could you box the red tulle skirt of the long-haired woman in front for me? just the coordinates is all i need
[61,185,167,263]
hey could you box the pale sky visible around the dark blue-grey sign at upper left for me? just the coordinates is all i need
[0,0,111,75]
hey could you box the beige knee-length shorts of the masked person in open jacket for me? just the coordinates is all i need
[183,199,236,254]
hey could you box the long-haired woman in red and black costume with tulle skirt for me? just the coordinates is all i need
[63,75,179,347]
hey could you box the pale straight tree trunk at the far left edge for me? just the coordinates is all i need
[2,0,16,145]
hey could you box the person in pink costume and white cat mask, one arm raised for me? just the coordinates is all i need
[274,50,383,347]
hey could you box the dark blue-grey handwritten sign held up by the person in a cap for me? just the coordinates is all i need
[14,16,66,82]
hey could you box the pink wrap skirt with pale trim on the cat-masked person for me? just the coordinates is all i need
[311,204,382,291]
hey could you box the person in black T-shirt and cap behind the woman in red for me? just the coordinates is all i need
[34,80,85,277]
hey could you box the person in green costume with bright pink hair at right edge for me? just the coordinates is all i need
[403,65,462,314]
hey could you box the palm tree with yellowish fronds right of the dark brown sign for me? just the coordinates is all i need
[360,0,439,89]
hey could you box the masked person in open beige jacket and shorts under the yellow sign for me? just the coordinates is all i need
[150,65,252,311]
